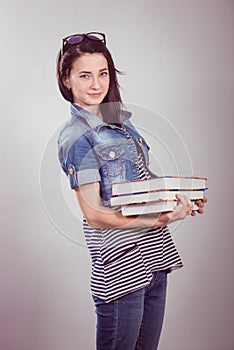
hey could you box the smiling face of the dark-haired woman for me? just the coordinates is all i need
[64,53,110,109]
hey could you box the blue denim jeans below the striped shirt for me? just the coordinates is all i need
[94,271,167,350]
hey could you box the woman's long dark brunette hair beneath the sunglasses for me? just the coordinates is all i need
[56,37,122,123]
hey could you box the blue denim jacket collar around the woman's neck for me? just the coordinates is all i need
[70,103,132,129]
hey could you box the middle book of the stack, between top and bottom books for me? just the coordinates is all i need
[110,188,206,206]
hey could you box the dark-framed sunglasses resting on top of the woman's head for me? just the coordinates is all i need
[61,32,106,56]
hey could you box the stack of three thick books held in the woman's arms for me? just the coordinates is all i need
[111,176,207,216]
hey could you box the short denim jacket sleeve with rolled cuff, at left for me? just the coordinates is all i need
[66,136,100,189]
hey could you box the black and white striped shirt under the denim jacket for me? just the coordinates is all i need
[83,141,182,302]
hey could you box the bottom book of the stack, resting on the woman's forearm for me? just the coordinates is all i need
[121,201,198,216]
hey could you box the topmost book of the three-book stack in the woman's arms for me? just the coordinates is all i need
[112,176,207,196]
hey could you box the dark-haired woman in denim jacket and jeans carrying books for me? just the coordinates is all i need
[57,32,206,350]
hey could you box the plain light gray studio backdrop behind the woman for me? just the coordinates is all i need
[0,0,234,350]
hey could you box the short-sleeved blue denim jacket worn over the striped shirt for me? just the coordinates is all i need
[58,104,152,205]
